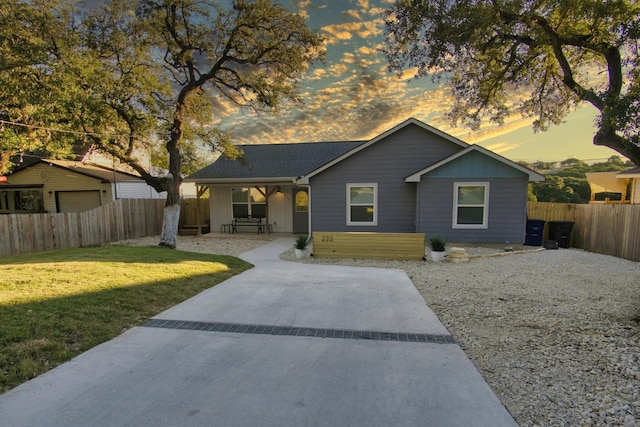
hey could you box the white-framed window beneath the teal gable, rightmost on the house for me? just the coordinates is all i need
[453,182,489,228]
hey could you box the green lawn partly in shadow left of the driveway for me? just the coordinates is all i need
[0,246,251,393]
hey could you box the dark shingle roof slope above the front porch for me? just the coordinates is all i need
[187,141,365,181]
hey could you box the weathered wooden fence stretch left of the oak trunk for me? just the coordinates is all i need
[0,199,165,257]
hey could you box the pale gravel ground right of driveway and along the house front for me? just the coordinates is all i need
[115,235,640,426]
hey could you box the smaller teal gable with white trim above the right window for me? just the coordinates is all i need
[405,145,544,182]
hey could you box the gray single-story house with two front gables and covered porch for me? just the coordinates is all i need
[186,118,544,243]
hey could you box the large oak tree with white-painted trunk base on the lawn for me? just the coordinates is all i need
[0,0,323,247]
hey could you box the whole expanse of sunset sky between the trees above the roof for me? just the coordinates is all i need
[218,0,617,163]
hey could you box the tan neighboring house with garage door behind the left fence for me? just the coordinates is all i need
[0,159,166,214]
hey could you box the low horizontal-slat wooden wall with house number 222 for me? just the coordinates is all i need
[313,231,425,260]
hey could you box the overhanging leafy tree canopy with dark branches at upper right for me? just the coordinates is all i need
[385,0,640,165]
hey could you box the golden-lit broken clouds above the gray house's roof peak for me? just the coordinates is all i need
[209,0,544,152]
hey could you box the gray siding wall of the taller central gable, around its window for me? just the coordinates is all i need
[309,125,462,233]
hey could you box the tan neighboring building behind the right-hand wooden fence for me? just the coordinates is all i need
[585,168,640,203]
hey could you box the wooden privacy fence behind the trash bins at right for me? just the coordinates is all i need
[528,202,640,261]
